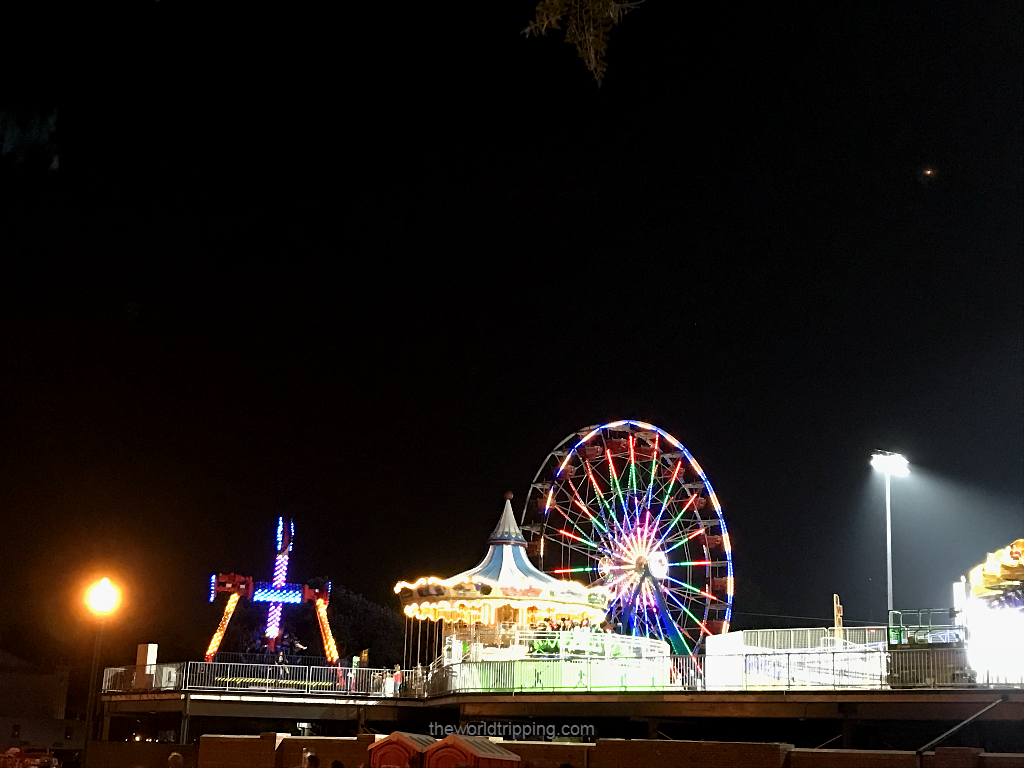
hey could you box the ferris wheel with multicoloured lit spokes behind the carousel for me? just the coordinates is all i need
[522,420,733,654]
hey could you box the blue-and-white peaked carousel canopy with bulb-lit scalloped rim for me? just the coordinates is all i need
[394,500,609,625]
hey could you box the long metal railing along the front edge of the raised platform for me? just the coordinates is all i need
[102,648,1024,698]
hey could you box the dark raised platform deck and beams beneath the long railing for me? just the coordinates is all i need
[102,689,1024,765]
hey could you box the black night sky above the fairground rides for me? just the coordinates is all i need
[0,0,1024,663]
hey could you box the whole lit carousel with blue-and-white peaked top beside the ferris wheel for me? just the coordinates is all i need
[394,494,671,693]
